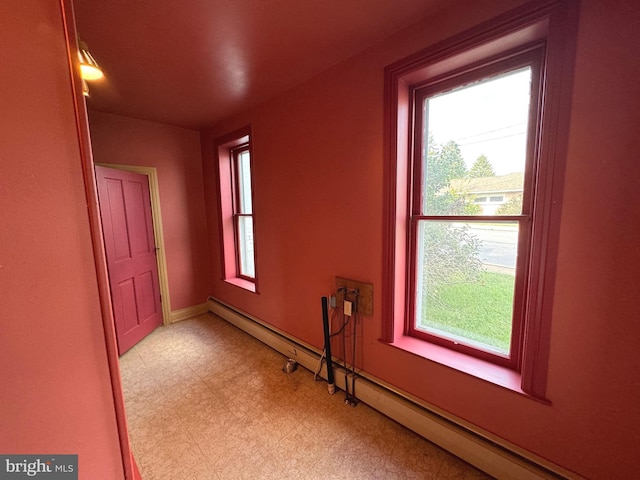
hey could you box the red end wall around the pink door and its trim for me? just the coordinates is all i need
[89,112,211,311]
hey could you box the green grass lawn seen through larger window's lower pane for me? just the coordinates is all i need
[419,272,514,353]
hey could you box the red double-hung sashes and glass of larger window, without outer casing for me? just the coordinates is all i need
[407,57,542,368]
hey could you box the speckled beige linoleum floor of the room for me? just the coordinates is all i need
[120,314,490,480]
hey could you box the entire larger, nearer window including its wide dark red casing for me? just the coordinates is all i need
[383,2,576,398]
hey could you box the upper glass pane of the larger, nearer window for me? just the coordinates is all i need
[422,67,531,215]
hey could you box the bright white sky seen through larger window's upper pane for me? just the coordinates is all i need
[428,68,531,175]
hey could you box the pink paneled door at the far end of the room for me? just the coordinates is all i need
[96,166,162,355]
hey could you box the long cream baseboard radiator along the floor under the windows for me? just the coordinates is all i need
[207,297,583,480]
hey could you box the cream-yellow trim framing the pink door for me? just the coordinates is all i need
[96,163,171,325]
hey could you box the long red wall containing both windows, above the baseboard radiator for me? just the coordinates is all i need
[202,0,640,479]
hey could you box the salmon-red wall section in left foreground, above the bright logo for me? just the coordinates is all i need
[0,0,124,479]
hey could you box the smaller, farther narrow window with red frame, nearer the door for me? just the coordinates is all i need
[216,127,257,292]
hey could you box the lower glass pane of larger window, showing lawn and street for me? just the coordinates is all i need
[415,221,518,355]
